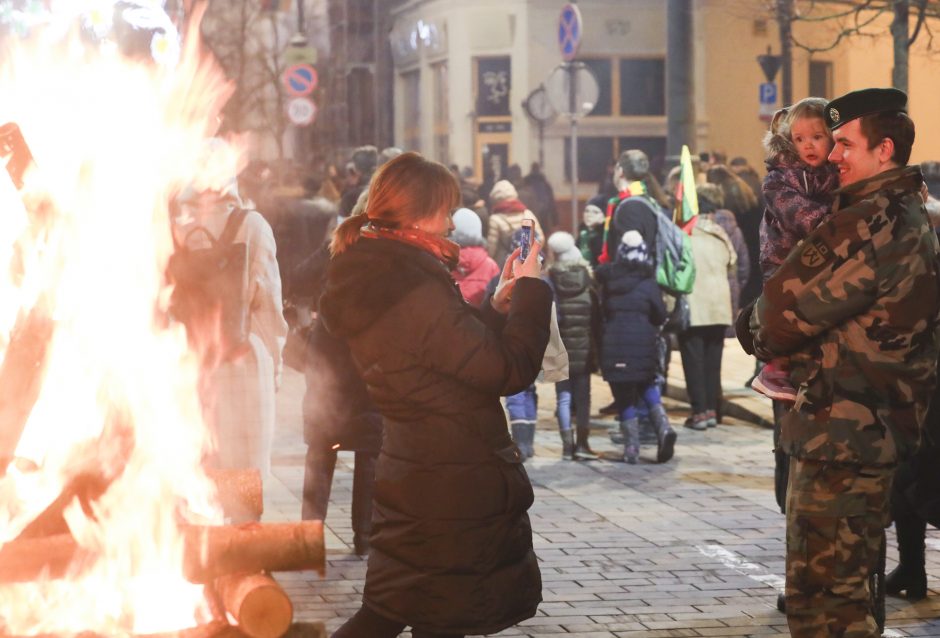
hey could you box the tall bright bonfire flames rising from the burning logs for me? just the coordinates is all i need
[0,0,246,635]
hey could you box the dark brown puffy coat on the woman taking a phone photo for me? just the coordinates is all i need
[320,239,552,634]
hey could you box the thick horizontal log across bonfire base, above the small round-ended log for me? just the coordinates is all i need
[0,521,325,583]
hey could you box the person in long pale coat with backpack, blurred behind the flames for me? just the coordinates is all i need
[173,140,287,490]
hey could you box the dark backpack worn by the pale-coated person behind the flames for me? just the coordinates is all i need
[167,209,249,360]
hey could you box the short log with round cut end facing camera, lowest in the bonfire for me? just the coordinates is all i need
[215,573,294,638]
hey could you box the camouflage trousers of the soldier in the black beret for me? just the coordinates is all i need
[786,459,895,638]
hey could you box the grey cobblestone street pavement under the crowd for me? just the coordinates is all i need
[265,358,940,638]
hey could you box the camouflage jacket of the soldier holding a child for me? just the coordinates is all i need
[750,167,940,466]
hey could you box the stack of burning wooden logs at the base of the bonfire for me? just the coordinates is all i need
[0,471,326,638]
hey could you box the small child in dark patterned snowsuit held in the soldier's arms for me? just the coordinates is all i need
[751,97,839,401]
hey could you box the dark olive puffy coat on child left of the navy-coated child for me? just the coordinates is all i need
[548,263,596,374]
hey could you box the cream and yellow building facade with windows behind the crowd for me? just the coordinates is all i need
[379,0,940,225]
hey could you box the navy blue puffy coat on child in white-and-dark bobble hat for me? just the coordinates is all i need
[595,262,666,383]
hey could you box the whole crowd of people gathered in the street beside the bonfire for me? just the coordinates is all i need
[165,89,940,638]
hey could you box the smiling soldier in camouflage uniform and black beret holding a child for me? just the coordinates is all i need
[737,89,940,638]
